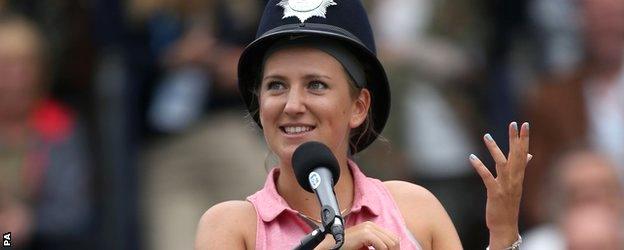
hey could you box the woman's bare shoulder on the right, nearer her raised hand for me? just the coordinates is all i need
[384,181,461,249]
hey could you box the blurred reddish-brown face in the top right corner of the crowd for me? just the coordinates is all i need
[581,0,624,65]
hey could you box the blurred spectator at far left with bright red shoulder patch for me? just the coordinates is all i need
[0,12,91,249]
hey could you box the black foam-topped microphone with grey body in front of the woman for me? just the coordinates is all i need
[292,141,344,249]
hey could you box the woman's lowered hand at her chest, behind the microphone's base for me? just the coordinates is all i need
[315,221,401,250]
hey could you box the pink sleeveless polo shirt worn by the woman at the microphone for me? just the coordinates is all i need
[247,160,422,250]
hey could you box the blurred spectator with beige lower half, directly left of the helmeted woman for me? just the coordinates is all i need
[134,0,267,249]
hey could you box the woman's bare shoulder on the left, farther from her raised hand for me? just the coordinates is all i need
[195,201,256,249]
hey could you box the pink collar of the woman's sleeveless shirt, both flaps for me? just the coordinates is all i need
[248,160,381,222]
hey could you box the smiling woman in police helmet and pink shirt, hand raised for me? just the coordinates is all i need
[196,0,529,249]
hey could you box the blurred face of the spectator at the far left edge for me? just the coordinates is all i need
[0,22,41,119]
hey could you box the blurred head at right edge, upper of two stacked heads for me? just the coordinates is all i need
[559,153,624,211]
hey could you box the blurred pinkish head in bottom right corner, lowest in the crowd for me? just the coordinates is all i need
[562,205,624,250]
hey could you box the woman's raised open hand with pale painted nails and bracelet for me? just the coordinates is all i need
[470,122,532,250]
